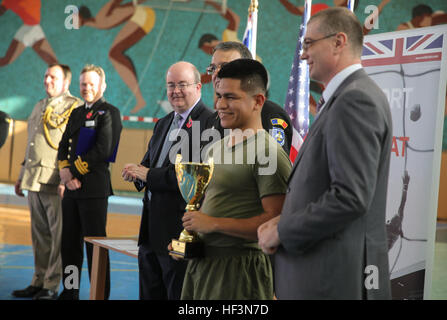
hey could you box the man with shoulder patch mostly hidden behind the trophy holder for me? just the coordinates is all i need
[207,41,293,155]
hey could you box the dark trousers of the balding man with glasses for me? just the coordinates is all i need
[138,245,187,300]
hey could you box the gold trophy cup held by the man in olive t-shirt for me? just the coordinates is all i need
[169,154,214,259]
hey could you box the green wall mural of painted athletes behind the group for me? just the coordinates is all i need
[0,0,447,144]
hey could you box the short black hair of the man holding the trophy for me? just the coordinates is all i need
[217,59,267,94]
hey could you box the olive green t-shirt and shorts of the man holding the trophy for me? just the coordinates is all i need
[182,130,291,299]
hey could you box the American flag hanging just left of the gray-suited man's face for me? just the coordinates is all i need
[284,0,312,162]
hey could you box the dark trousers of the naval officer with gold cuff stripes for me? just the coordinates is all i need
[61,197,110,299]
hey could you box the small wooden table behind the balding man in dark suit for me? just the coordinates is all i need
[84,237,138,300]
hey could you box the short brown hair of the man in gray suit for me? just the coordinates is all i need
[308,7,363,56]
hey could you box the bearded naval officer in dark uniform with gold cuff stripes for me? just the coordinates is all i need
[57,65,122,300]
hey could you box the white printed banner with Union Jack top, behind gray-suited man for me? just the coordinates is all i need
[362,25,447,299]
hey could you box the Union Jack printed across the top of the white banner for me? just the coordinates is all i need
[362,31,444,67]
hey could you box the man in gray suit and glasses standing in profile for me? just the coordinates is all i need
[258,8,392,299]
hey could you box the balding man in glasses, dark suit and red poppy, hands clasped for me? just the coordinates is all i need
[123,61,212,300]
